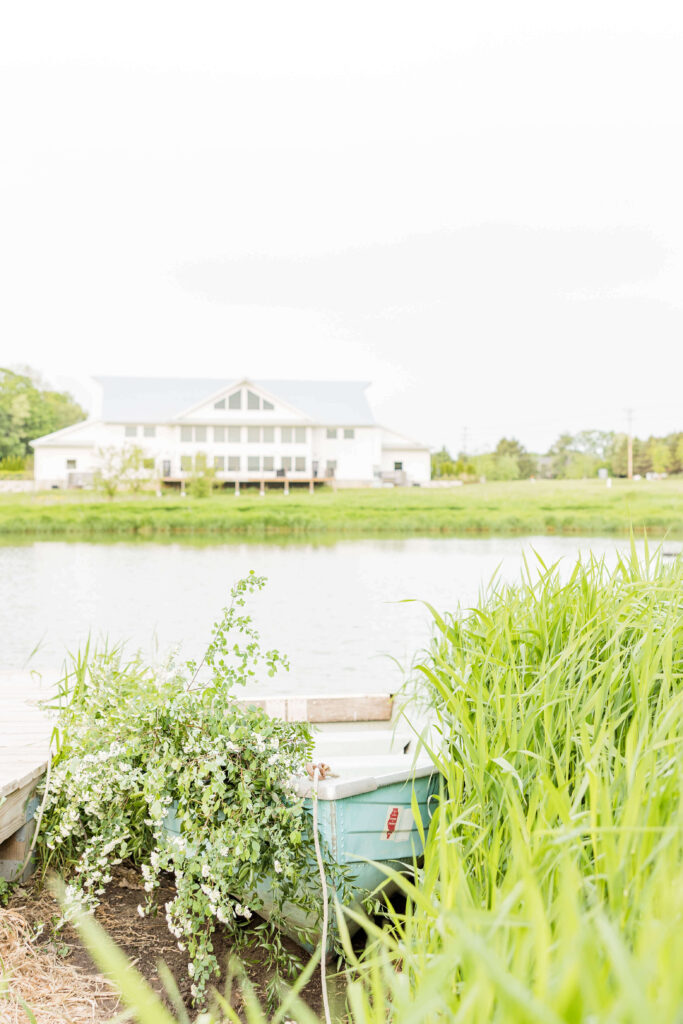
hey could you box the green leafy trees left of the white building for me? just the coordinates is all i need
[0,368,85,458]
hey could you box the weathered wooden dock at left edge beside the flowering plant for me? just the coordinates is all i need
[0,673,52,880]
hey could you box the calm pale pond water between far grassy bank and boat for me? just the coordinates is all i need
[0,537,651,692]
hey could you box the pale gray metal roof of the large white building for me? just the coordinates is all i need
[95,377,375,426]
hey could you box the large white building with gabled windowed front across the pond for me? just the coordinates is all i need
[32,377,431,487]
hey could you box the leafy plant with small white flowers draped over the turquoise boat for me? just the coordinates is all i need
[39,572,333,998]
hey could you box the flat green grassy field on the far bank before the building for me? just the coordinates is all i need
[0,479,683,538]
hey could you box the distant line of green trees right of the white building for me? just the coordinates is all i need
[432,430,683,480]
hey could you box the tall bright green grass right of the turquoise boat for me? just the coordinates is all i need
[342,540,683,1024]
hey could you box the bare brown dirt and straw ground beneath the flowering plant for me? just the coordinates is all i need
[6,865,323,1024]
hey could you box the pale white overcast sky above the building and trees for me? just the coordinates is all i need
[0,0,683,451]
